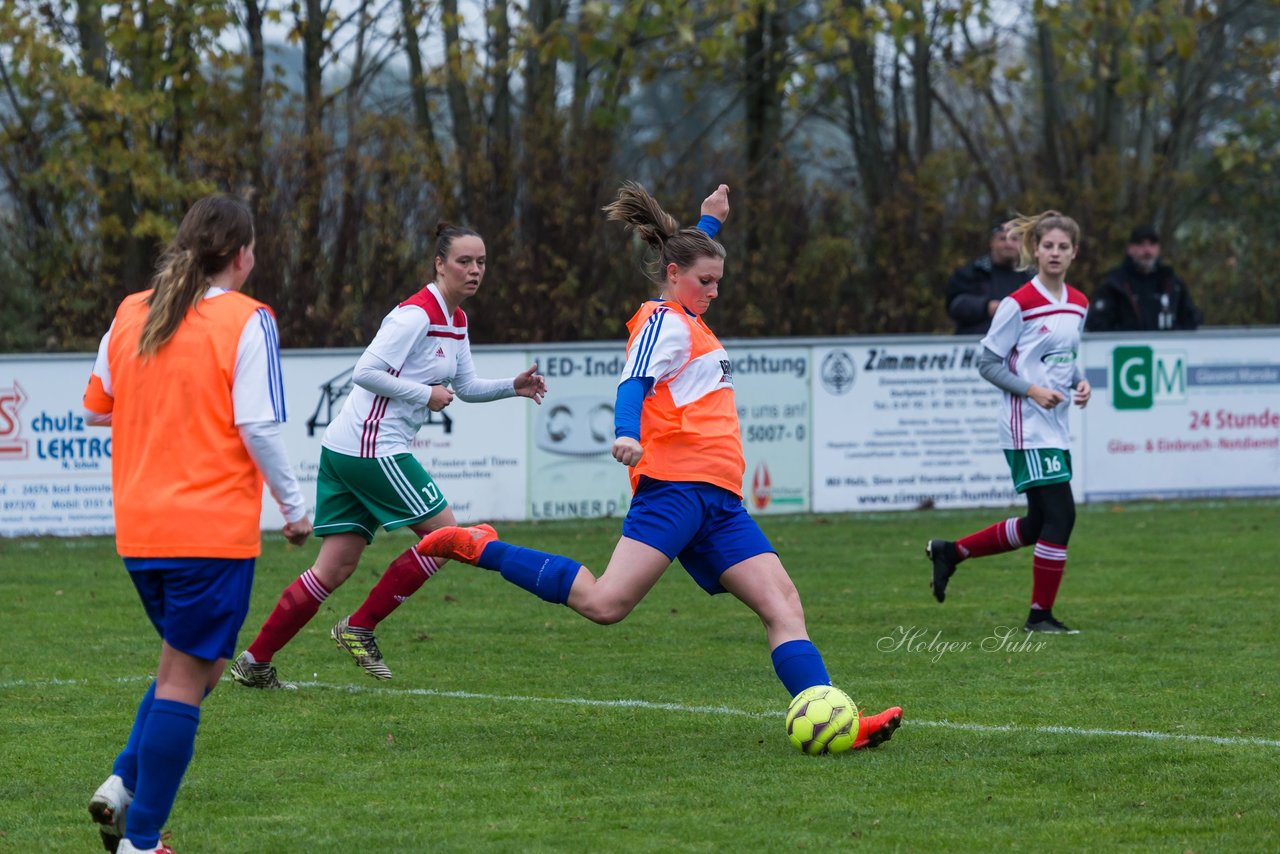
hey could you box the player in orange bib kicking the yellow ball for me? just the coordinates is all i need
[419,183,902,748]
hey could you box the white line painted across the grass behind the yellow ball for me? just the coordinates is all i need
[0,676,1280,748]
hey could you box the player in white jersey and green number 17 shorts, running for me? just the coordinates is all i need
[232,223,547,689]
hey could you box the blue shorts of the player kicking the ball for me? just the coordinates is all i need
[622,478,777,595]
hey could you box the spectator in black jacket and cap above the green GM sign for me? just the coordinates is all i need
[1085,225,1202,332]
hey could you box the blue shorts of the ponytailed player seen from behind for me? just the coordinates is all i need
[124,557,255,661]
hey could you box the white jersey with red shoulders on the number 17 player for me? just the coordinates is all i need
[321,283,494,457]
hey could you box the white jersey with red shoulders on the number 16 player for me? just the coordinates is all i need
[982,277,1089,451]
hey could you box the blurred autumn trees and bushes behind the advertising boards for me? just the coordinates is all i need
[0,0,1280,351]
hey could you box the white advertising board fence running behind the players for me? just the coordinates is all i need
[0,328,1280,536]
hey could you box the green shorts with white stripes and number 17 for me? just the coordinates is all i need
[315,448,449,543]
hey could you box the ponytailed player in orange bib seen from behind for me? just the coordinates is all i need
[84,196,311,854]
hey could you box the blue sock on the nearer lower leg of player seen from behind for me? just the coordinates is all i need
[124,701,200,848]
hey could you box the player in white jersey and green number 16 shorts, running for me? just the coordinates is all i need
[925,210,1092,635]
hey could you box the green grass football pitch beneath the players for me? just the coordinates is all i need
[0,501,1280,854]
